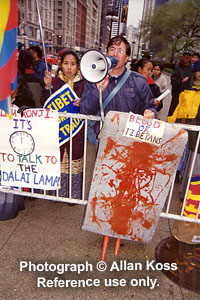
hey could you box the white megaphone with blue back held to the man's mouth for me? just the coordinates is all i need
[80,50,118,83]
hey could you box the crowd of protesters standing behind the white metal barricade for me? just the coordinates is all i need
[0,35,200,220]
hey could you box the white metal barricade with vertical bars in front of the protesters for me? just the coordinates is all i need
[0,113,200,224]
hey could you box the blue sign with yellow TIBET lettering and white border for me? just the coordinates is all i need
[44,84,83,146]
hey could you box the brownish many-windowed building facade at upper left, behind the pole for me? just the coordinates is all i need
[18,0,102,54]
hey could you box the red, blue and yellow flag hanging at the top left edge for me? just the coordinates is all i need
[0,0,18,114]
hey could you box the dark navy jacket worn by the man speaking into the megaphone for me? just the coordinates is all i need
[80,68,157,115]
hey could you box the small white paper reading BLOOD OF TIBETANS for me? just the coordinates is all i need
[123,112,165,146]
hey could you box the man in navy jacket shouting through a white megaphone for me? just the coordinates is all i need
[80,35,157,142]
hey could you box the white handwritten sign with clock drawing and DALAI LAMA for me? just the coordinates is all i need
[0,108,60,190]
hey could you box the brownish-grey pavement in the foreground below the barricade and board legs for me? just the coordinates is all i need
[0,73,199,300]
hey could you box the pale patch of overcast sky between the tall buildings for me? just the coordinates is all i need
[127,0,144,27]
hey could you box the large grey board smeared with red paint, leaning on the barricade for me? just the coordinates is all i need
[82,111,188,243]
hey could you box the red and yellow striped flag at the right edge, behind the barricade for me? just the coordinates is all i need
[183,175,200,219]
